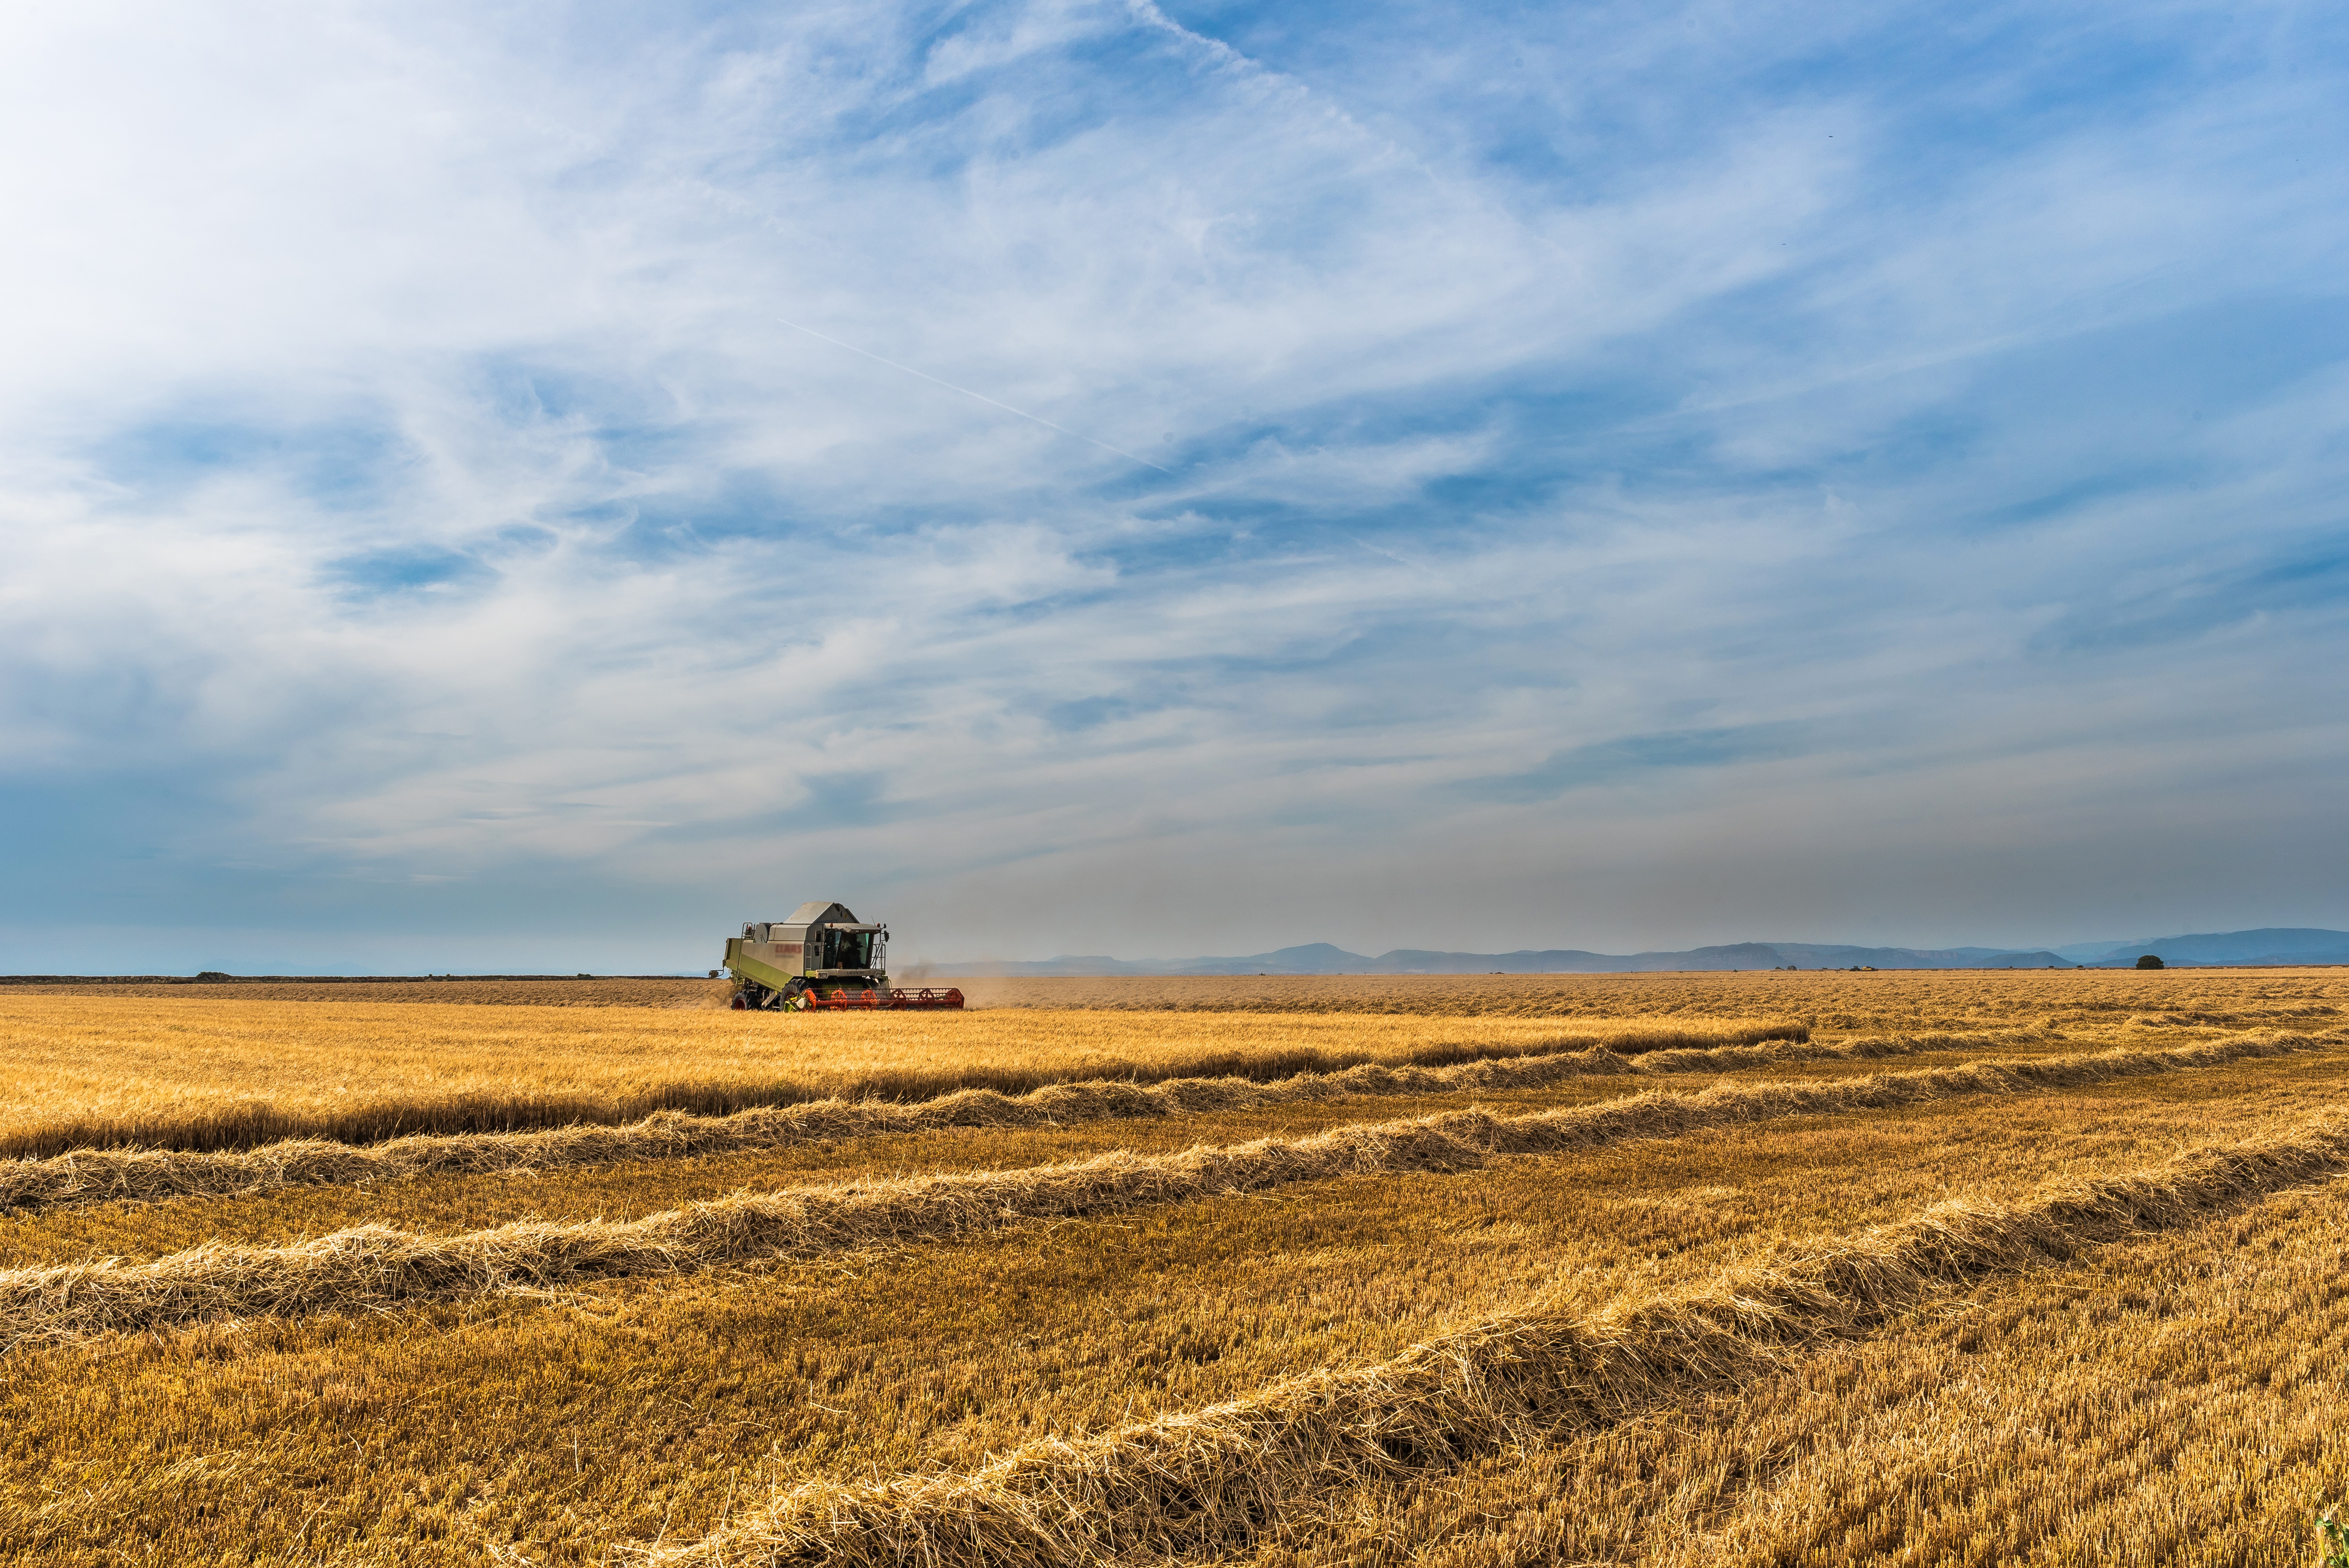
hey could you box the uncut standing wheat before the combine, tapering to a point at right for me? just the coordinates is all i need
[0,995,1809,1157]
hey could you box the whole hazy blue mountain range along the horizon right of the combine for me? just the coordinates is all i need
[928,927,2349,976]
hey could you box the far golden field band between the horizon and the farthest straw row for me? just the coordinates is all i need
[14,969,2349,1157]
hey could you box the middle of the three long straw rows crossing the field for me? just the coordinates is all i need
[0,1035,2328,1347]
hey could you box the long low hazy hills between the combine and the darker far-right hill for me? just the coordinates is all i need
[930,941,2076,976]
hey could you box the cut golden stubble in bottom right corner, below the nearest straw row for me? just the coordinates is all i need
[1250,1181,2349,1568]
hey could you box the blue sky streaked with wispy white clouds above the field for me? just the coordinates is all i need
[0,2,2349,972]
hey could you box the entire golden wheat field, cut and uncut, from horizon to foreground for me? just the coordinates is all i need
[0,972,2349,1568]
